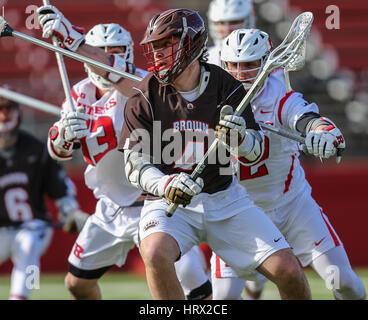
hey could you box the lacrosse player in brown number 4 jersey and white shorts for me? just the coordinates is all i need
[120,9,311,299]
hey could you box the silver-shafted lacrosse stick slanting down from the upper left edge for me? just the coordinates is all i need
[0,16,142,82]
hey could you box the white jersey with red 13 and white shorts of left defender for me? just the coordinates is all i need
[63,74,141,270]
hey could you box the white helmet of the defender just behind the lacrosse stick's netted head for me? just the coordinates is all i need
[220,29,272,91]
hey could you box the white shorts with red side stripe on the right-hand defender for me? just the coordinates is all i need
[211,185,342,278]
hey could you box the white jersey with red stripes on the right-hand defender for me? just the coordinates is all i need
[238,69,318,211]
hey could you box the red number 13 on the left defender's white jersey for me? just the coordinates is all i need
[81,117,118,166]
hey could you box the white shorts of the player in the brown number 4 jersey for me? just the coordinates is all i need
[139,179,290,279]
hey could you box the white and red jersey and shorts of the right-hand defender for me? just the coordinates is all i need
[211,69,341,278]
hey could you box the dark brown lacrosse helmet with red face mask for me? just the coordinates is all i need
[140,9,208,85]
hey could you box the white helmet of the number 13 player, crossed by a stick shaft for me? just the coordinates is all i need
[84,23,134,90]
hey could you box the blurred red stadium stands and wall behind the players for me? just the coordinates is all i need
[0,0,368,273]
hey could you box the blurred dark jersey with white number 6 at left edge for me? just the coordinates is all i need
[0,131,73,227]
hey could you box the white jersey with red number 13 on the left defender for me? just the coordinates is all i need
[63,70,146,206]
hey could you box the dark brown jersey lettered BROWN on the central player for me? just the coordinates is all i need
[119,63,259,193]
